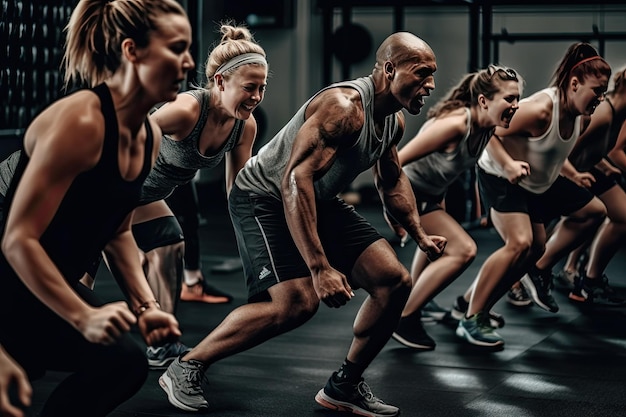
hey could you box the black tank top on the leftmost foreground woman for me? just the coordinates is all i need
[0,83,154,284]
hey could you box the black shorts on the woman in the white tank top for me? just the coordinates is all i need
[477,167,594,224]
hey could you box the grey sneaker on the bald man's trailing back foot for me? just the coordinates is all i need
[159,358,209,411]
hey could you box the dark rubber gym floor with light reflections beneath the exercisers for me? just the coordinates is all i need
[29,193,626,417]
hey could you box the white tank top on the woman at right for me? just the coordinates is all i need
[478,87,582,194]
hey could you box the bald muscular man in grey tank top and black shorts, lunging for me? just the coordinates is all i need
[159,32,446,416]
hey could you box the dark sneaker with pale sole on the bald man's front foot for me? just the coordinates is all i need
[315,372,400,417]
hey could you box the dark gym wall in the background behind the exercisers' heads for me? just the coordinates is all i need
[0,0,626,174]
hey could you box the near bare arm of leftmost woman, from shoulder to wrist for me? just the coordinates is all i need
[2,93,104,328]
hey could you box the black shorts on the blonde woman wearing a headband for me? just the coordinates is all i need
[133,216,184,252]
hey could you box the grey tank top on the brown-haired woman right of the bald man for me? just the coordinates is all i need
[402,107,494,195]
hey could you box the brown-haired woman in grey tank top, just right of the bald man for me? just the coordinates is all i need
[385,66,521,350]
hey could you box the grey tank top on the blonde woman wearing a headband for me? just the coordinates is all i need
[141,89,246,204]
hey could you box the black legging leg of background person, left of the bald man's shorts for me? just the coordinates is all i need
[165,182,201,270]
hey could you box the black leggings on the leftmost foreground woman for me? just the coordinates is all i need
[0,284,148,417]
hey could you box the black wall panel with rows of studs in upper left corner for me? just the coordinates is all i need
[0,0,76,158]
